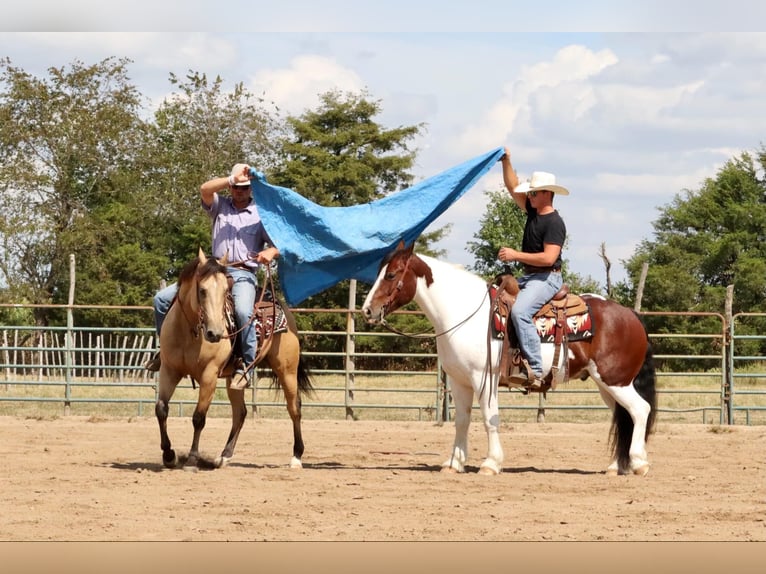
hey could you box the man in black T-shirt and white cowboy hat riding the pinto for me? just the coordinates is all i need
[497,147,569,388]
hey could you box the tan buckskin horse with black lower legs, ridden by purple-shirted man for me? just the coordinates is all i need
[155,249,313,470]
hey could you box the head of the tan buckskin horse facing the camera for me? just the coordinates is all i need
[178,249,230,343]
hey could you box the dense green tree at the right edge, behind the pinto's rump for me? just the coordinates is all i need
[626,148,766,366]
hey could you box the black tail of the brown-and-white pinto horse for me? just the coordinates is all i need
[612,315,657,469]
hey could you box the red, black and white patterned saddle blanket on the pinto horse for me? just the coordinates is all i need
[489,283,593,343]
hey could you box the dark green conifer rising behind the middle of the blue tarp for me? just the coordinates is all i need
[268,91,428,368]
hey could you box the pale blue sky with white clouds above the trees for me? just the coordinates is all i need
[0,0,766,284]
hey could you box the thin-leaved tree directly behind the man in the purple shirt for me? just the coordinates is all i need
[142,71,284,288]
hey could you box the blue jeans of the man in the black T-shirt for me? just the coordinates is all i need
[511,272,564,377]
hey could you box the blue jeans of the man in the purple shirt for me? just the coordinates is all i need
[154,267,258,366]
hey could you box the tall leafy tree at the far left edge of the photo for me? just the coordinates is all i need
[0,58,145,324]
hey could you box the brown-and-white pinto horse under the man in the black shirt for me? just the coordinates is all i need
[362,243,656,475]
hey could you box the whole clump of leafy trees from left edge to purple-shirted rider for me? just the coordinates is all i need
[0,62,282,325]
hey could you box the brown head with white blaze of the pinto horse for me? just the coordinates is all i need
[362,242,433,323]
